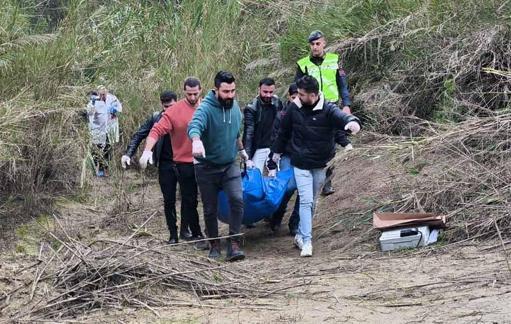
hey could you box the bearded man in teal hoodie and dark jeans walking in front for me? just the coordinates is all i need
[188,71,248,261]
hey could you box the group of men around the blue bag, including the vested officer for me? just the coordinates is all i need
[121,31,360,261]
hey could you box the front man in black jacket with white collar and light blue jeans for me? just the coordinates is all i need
[272,75,360,257]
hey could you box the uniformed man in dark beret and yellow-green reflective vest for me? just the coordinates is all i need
[295,30,353,196]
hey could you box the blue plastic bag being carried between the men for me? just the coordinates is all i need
[218,168,293,224]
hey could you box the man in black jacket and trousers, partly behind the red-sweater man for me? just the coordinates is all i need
[121,91,192,244]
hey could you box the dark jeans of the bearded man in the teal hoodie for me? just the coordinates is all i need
[195,163,243,238]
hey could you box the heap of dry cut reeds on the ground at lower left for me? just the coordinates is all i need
[0,212,308,322]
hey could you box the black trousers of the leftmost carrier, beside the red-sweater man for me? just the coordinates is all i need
[158,163,179,239]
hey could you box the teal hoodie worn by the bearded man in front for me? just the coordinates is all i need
[188,90,241,165]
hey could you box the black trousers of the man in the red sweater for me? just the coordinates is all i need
[174,163,202,236]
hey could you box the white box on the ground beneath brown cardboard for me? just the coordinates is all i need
[380,226,429,251]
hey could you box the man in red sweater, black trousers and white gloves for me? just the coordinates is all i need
[140,77,204,247]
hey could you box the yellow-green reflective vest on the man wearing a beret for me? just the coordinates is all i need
[297,53,339,102]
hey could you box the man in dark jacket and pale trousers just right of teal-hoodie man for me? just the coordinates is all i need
[243,78,282,174]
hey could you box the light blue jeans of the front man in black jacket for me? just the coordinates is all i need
[294,167,325,243]
